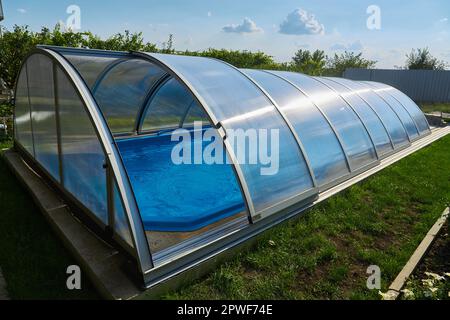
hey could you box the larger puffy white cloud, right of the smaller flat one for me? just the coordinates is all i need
[279,8,325,35]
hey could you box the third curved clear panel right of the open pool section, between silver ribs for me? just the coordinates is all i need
[276,71,377,171]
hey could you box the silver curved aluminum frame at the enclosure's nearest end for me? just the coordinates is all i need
[16,47,153,275]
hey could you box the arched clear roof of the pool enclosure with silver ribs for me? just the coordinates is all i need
[15,46,430,282]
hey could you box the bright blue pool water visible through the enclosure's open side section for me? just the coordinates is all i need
[117,134,245,232]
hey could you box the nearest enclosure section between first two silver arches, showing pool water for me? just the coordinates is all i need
[50,48,253,264]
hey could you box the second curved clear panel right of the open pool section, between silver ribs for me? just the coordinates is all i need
[245,70,349,186]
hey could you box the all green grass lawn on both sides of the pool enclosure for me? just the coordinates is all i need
[0,136,450,299]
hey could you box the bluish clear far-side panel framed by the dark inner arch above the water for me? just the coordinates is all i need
[140,78,195,131]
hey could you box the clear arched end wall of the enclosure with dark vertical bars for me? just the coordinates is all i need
[15,50,139,255]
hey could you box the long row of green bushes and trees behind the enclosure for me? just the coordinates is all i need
[0,25,376,95]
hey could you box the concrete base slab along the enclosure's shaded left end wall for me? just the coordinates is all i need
[0,150,142,300]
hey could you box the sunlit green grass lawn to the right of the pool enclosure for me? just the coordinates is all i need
[165,136,450,299]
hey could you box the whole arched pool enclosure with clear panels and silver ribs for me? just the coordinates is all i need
[14,46,430,287]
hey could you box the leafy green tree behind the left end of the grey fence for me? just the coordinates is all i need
[325,51,377,77]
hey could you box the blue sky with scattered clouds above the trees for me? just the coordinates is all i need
[2,0,450,68]
